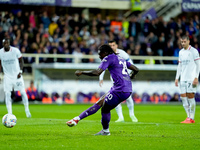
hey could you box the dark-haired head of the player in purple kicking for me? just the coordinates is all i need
[98,44,115,60]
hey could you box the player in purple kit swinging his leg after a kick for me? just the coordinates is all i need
[66,44,139,135]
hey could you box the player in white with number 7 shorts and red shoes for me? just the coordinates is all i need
[175,36,200,123]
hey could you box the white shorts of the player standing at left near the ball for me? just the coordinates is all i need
[3,76,25,92]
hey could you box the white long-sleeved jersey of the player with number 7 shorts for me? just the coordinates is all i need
[179,45,200,81]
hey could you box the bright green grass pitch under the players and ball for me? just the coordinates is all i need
[0,103,200,150]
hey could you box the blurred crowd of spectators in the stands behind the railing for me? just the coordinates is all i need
[0,10,200,63]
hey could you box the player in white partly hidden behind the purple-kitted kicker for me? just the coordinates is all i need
[99,41,138,122]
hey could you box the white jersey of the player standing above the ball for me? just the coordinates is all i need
[0,46,22,79]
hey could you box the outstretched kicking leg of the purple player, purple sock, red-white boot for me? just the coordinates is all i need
[66,94,106,127]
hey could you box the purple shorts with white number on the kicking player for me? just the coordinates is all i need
[105,90,131,109]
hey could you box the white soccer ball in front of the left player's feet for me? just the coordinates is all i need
[2,114,17,128]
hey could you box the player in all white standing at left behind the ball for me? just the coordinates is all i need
[0,38,31,118]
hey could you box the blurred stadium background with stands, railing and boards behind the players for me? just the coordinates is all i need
[0,0,200,104]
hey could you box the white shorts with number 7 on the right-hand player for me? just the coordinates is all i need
[180,81,197,94]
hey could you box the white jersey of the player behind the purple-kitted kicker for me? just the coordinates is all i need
[99,49,133,80]
